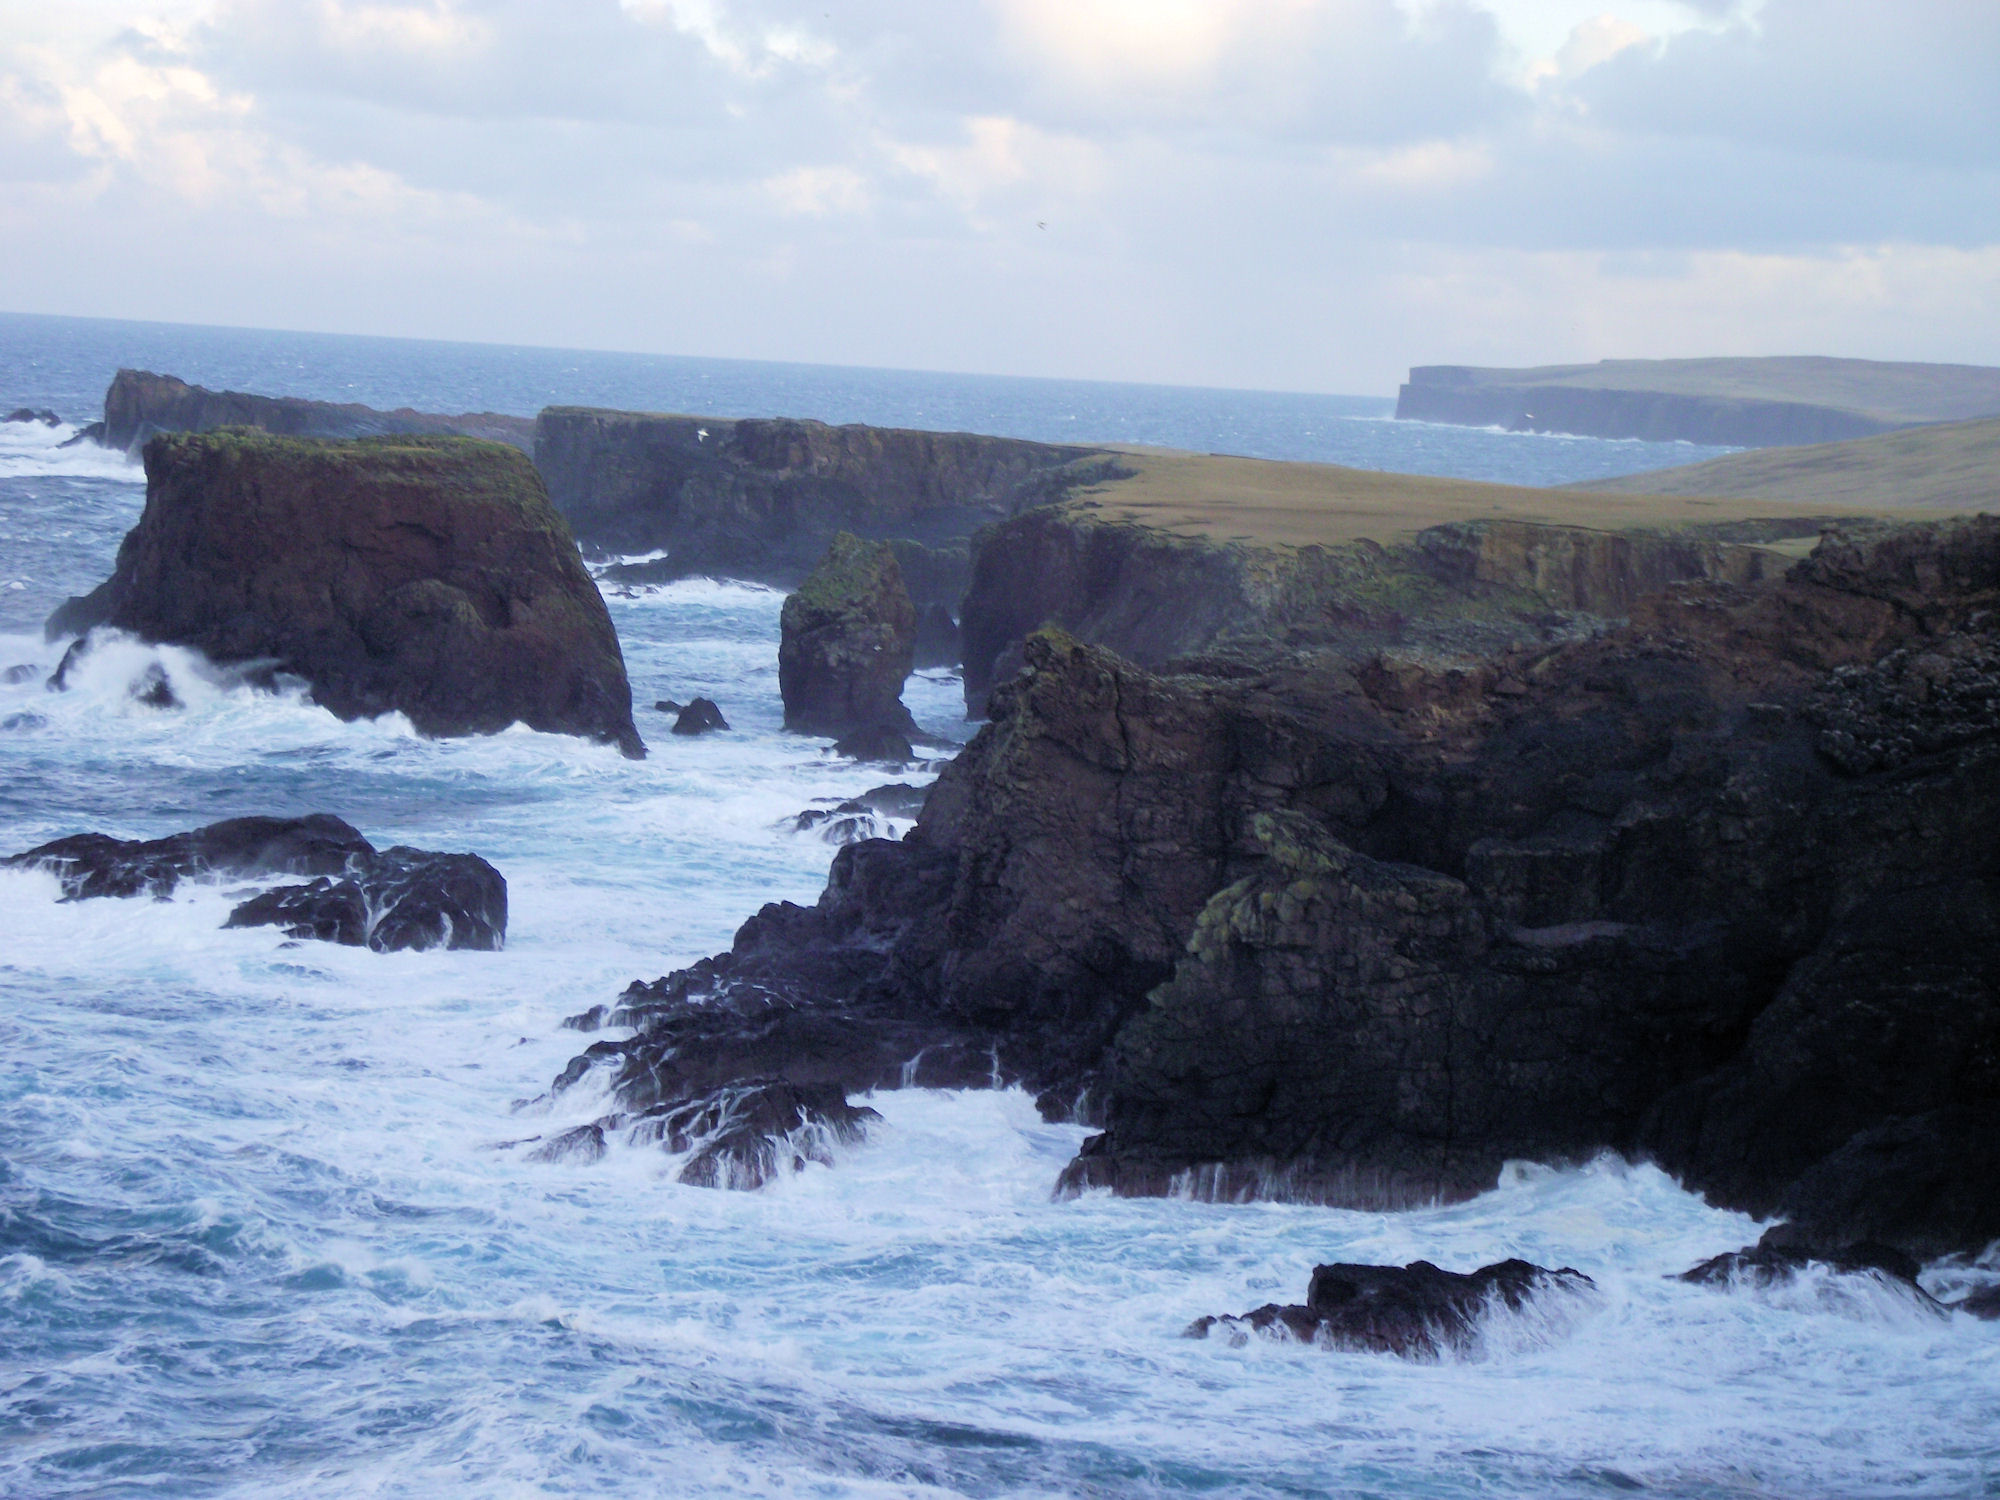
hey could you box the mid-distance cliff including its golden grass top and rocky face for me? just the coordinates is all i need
[960,448,1928,712]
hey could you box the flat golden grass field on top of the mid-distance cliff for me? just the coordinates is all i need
[1070,446,1946,546]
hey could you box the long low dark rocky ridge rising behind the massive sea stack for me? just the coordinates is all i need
[94,370,534,452]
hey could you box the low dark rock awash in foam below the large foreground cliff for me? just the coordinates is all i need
[1188,1260,1596,1360]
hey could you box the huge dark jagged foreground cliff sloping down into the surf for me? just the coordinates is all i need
[548,518,2000,1254]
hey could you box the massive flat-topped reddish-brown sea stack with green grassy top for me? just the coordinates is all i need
[48,430,644,756]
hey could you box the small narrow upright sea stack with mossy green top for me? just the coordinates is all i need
[778,532,916,740]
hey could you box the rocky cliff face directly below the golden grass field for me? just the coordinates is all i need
[960,506,1772,712]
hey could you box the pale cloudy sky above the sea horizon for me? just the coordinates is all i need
[0,0,2000,394]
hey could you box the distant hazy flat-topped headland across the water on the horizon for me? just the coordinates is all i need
[1396,356,2000,448]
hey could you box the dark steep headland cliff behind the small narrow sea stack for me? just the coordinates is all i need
[536,406,1112,608]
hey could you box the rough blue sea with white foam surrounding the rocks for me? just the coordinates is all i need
[0,318,2000,1500]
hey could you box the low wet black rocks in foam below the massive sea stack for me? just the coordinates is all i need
[0,812,506,954]
